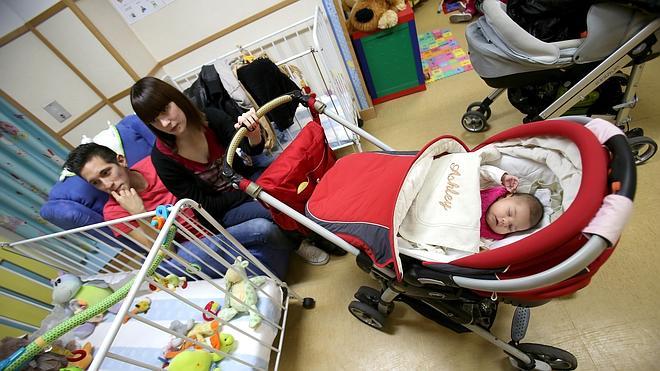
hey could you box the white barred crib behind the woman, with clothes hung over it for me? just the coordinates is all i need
[168,7,361,151]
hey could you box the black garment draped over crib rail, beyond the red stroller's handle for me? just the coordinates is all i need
[236,58,300,130]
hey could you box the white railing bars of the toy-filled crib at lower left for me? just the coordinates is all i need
[2,200,301,370]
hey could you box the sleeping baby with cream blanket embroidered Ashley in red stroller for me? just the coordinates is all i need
[399,153,544,255]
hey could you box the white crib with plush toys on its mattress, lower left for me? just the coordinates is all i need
[2,200,306,370]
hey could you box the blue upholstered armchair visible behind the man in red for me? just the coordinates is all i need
[40,115,156,229]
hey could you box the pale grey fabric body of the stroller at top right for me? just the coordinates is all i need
[465,0,655,81]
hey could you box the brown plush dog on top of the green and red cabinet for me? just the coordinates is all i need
[348,0,406,32]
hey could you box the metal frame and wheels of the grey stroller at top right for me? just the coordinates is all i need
[461,0,660,165]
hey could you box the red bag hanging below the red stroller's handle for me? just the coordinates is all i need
[256,121,336,234]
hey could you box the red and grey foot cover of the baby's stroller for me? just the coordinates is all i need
[306,152,416,267]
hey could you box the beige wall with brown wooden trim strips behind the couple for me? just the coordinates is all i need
[0,0,310,146]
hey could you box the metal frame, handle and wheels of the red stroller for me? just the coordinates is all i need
[225,92,636,370]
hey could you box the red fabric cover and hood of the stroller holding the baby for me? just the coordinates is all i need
[306,121,612,298]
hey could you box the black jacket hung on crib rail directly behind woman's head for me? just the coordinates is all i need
[183,65,245,120]
